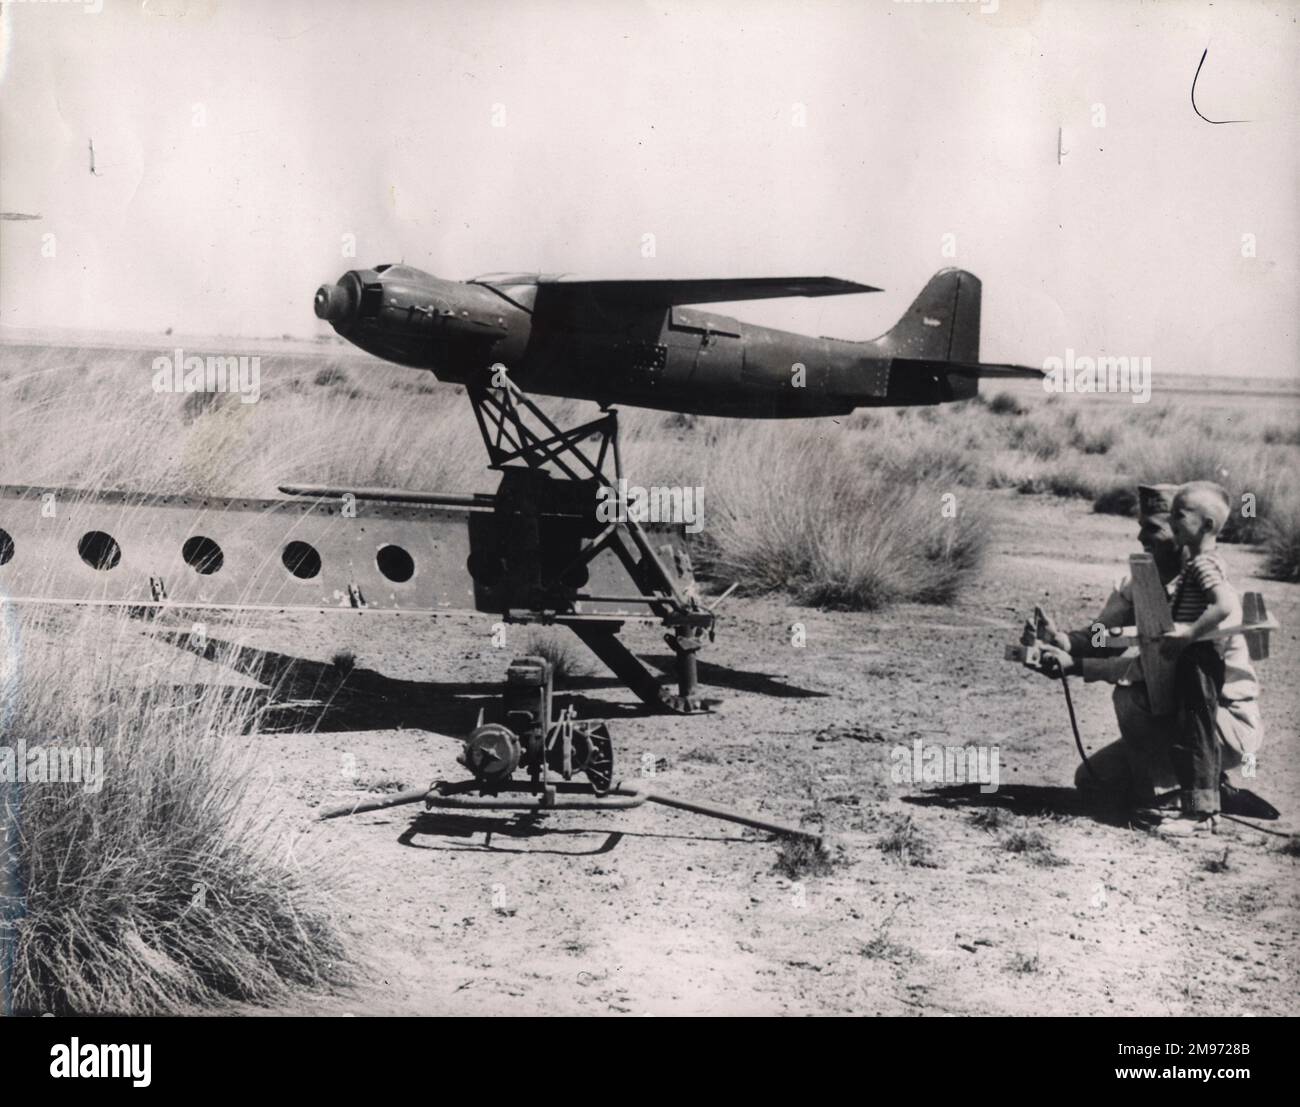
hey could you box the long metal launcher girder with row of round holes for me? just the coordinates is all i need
[0,485,686,622]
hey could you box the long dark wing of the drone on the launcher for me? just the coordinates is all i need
[536,277,880,312]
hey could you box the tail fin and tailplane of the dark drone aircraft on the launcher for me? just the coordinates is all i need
[872,269,1043,403]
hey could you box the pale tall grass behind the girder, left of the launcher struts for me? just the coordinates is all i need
[0,348,489,498]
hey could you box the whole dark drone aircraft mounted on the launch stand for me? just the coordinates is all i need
[316,265,1043,418]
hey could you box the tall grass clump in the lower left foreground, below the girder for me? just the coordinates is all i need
[0,604,350,1015]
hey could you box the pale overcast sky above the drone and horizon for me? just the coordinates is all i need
[0,0,1300,375]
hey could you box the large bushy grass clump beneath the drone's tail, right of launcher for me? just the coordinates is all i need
[701,426,987,609]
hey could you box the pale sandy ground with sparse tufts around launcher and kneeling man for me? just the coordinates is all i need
[4,335,1300,1016]
